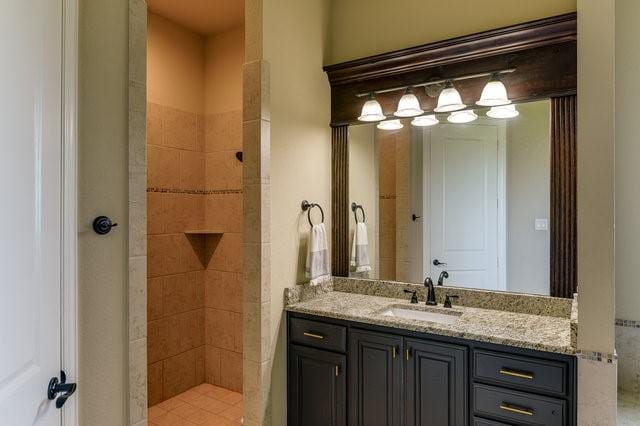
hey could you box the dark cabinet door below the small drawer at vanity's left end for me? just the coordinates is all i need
[288,344,347,426]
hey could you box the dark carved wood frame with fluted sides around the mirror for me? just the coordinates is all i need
[324,13,577,297]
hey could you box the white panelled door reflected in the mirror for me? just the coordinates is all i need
[427,124,498,289]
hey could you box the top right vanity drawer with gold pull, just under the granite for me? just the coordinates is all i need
[473,350,567,395]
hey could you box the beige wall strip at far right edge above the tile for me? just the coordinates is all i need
[615,0,640,321]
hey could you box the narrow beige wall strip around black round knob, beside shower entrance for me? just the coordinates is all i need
[77,0,129,426]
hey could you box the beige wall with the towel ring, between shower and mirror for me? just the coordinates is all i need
[263,0,331,425]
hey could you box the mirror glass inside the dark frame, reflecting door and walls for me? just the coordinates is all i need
[349,100,551,295]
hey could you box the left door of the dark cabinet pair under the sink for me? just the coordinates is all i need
[349,330,402,426]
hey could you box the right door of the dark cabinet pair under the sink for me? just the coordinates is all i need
[403,339,468,426]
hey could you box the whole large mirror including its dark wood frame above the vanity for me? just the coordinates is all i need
[326,14,577,297]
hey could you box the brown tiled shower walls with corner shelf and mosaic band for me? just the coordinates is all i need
[147,103,243,405]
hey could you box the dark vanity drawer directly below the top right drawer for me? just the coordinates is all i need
[473,384,567,426]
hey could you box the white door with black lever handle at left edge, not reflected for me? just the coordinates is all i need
[0,0,62,426]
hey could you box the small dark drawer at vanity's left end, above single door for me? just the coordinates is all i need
[289,318,347,352]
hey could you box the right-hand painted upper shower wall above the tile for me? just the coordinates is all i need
[204,27,244,114]
